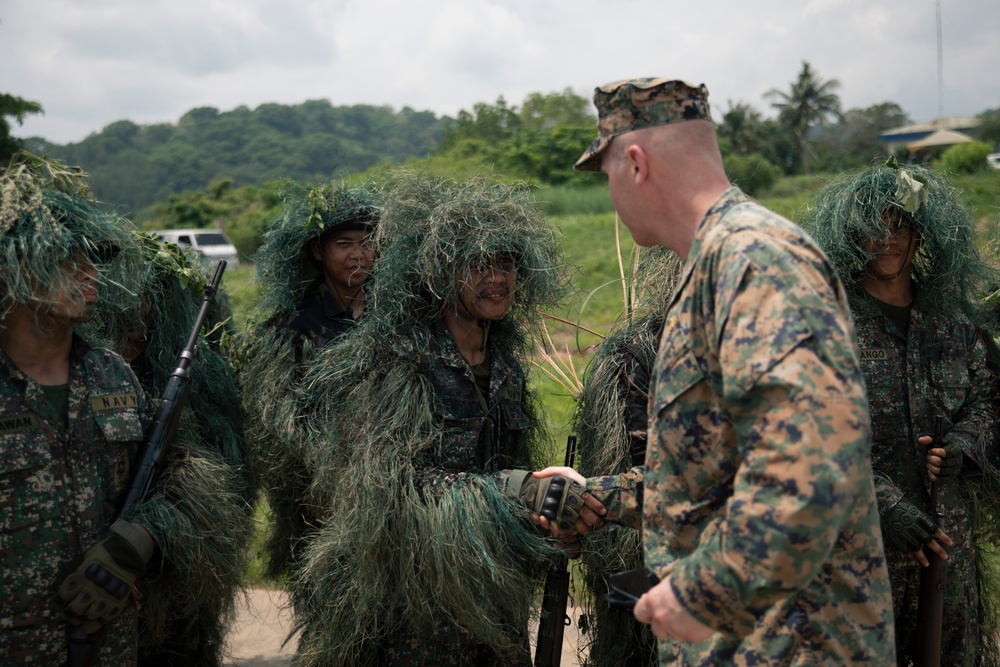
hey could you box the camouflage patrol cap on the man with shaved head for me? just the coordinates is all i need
[573,77,712,171]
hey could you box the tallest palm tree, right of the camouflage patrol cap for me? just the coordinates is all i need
[764,61,842,174]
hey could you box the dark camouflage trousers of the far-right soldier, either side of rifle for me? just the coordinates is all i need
[889,530,981,667]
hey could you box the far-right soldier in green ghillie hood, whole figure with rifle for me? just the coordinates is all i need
[809,161,1000,667]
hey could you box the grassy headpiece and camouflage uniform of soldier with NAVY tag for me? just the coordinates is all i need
[0,160,152,665]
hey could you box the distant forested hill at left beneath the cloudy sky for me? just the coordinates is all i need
[28,100,444,212]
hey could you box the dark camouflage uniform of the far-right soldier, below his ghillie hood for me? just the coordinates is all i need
[851,289,997,667]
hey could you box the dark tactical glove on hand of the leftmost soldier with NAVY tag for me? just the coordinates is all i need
[59,521,156,634]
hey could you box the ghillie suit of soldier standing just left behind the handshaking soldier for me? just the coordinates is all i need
[236,183,381,579]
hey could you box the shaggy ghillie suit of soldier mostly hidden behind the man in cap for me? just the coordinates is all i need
[574,248,682,667]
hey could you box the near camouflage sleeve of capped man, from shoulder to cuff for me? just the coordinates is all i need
[670,240,872,635]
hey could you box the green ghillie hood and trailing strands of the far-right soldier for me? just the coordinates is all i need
[803,159,1000,665]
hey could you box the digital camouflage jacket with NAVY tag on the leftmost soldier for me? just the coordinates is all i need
[0,337,150,665]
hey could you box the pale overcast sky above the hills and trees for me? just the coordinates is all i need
[0,0,1000,143]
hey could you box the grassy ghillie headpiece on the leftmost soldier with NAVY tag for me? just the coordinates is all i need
[0,157,139,321]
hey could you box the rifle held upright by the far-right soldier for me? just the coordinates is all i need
[913,415,948,667]
